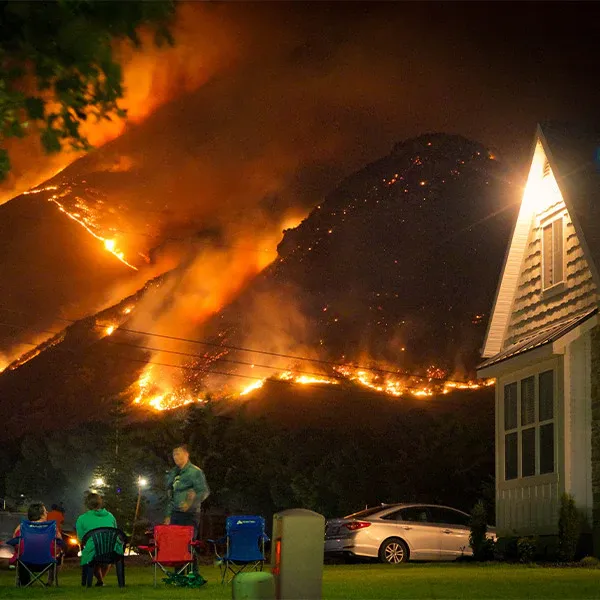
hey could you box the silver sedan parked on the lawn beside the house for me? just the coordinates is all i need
[325,504,496,564]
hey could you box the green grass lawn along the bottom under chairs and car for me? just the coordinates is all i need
[0,564,600,600]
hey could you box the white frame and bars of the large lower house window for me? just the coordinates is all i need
[498,362,560,485]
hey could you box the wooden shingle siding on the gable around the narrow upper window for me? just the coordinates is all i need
[503,207,598,348]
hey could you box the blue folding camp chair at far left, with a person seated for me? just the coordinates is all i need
[7,520,62,587]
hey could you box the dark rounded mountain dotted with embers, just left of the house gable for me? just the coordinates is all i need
[202,134,514,376]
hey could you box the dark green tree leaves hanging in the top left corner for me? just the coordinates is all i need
[0,0,174,178]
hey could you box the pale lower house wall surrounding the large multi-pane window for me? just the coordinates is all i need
[496,356,565,537]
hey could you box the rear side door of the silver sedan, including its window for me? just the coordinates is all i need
[384,506,440,560]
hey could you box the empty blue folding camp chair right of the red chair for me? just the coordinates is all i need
[208,515,269,583]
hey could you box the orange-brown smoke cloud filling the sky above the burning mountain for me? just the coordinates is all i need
[0,2,596,394]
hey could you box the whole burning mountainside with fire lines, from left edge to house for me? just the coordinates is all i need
[0,134,512,429]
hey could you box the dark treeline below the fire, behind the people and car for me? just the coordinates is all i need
[0,398,494,528]
